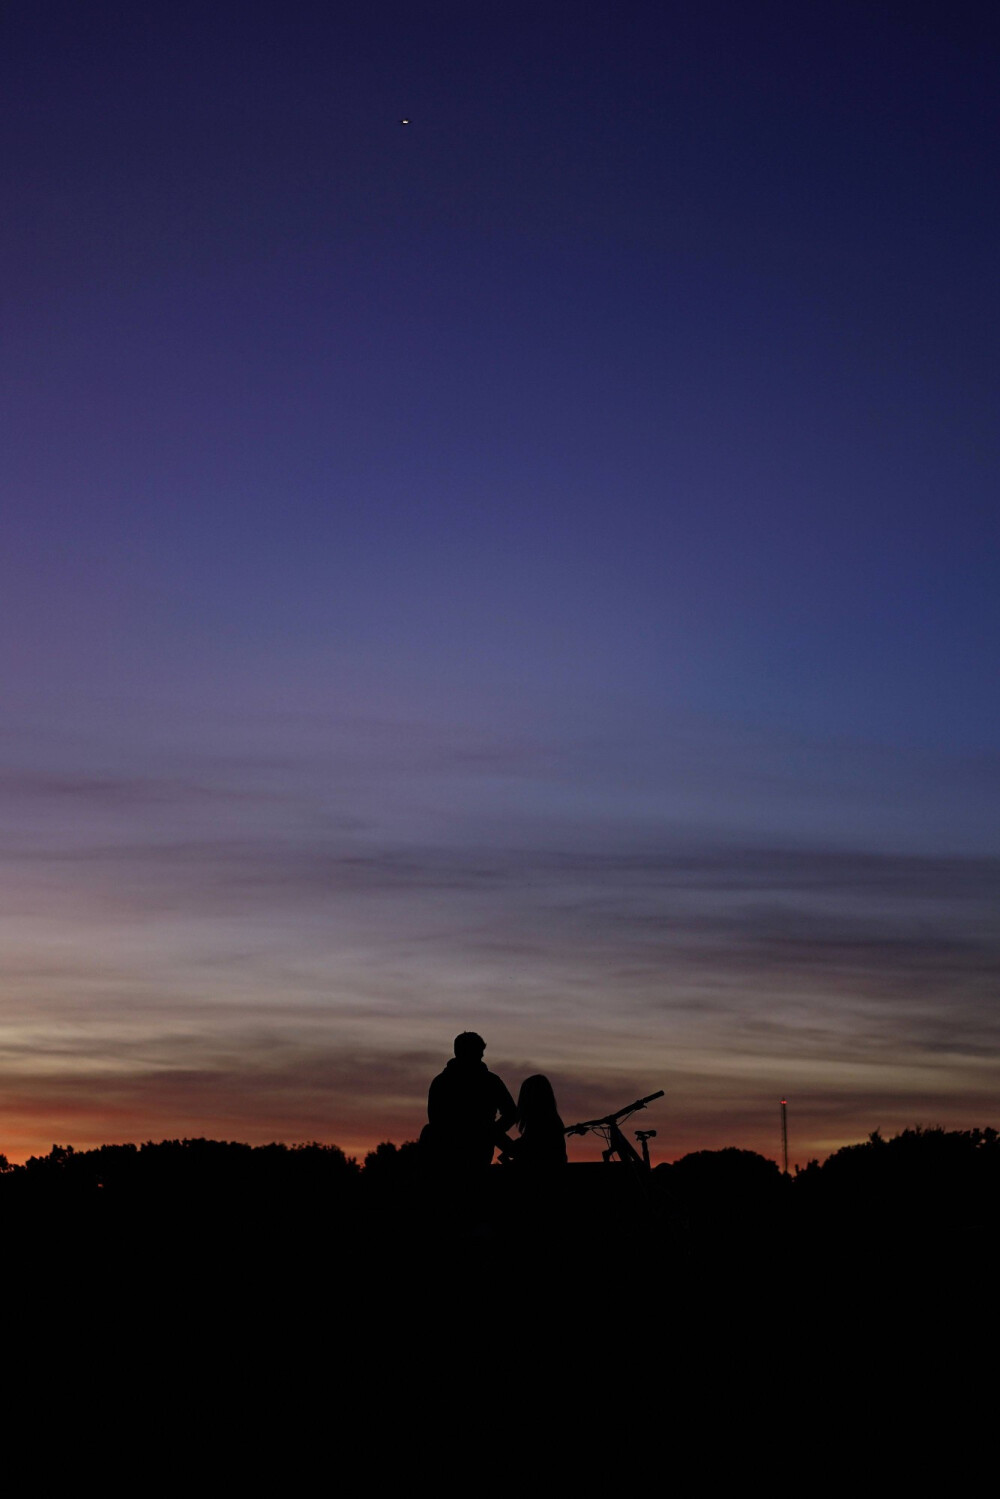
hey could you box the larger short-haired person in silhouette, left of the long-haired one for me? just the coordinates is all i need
[421,1031,517,1175]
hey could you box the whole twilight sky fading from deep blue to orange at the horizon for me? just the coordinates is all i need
[0,0,1000,1160]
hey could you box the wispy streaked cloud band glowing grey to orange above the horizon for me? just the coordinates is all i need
[0,726,1000,1148]
